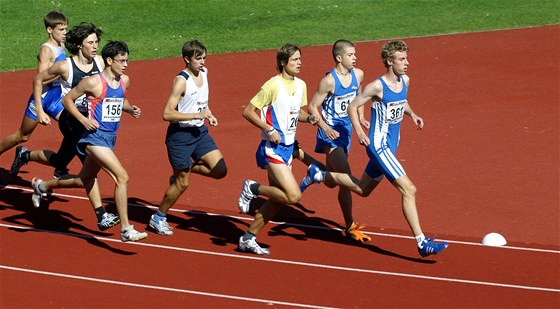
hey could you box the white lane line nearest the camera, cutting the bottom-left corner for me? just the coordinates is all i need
[0,265,336,309]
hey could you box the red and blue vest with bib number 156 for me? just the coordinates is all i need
[88,74,126,132]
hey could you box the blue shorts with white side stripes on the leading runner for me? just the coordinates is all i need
[366,144,406,182]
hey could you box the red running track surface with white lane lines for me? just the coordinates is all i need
[0,26,560,308]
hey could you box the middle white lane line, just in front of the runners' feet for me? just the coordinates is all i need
[0,223,560,293]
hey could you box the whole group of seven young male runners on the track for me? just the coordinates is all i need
[0,10,448,257]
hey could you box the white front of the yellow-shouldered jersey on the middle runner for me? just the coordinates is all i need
[261,76,305,145]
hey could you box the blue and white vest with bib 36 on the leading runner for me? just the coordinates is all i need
[368,77,408,151]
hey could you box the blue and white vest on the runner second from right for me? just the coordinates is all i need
[321,69,359,127]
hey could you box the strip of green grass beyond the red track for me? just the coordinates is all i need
[0,0,560,71]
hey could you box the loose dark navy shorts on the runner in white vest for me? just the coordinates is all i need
[165,123,218,171]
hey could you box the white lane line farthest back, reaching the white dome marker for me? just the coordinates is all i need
[0,186,560,254]
